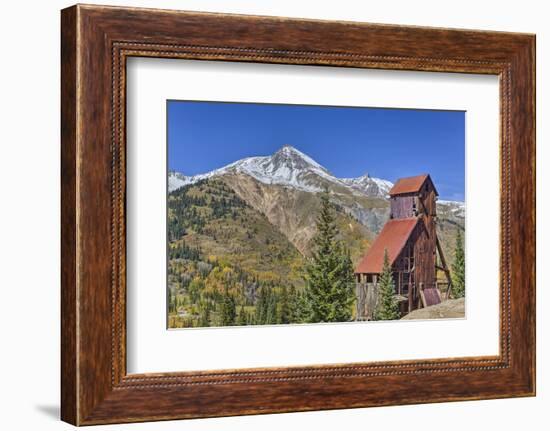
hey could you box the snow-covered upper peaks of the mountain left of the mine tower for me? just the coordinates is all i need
[168,145,393,197]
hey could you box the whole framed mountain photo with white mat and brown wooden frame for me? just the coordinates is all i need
[61,5,535,425]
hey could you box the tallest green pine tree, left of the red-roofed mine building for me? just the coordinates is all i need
[304,189,354,322]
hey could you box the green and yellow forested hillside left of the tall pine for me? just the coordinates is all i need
[168,179,303,327]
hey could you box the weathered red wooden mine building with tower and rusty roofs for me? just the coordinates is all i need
[355,174,451,320]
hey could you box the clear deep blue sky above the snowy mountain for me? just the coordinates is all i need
[167,100,465,200]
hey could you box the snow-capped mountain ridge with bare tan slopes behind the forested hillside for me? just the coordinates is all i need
[169,145,465,264]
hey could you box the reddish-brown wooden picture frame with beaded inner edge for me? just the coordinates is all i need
[61,6,535,425]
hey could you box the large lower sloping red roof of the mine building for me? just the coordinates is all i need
[355,217,420,274]
